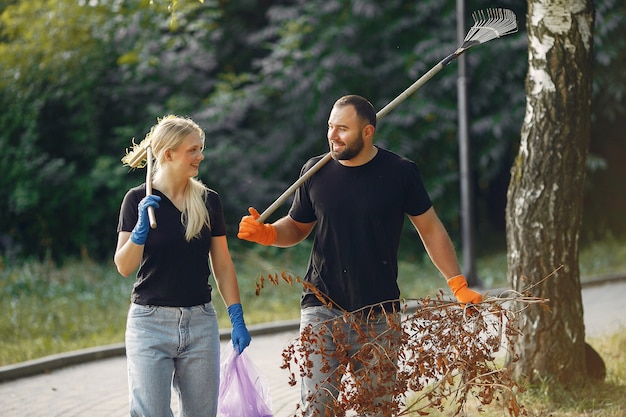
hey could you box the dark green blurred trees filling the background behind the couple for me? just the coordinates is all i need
[0,0,626,259]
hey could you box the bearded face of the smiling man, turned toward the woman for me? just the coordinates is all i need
[326,105,365,160]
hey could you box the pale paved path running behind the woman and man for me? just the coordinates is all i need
[0,280,626,417]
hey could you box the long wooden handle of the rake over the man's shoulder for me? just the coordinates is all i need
[257,49,464,223]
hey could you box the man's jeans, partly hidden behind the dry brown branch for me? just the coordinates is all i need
[298,306,400,416]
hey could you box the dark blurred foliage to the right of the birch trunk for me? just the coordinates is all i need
[581,0,626,239]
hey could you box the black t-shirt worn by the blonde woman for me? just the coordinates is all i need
[117,184,226,307]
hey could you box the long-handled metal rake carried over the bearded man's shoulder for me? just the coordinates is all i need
[258,9,517,223]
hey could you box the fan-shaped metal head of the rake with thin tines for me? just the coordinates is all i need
[459,9,517,50]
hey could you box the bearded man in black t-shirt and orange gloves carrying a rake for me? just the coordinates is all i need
[237,95,482,416]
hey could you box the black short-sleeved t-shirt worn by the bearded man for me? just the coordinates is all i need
[289,148,432,311]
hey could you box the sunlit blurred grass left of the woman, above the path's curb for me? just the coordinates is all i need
[0,262,132,365]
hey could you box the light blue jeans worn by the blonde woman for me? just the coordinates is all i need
[126,303,220,417]
